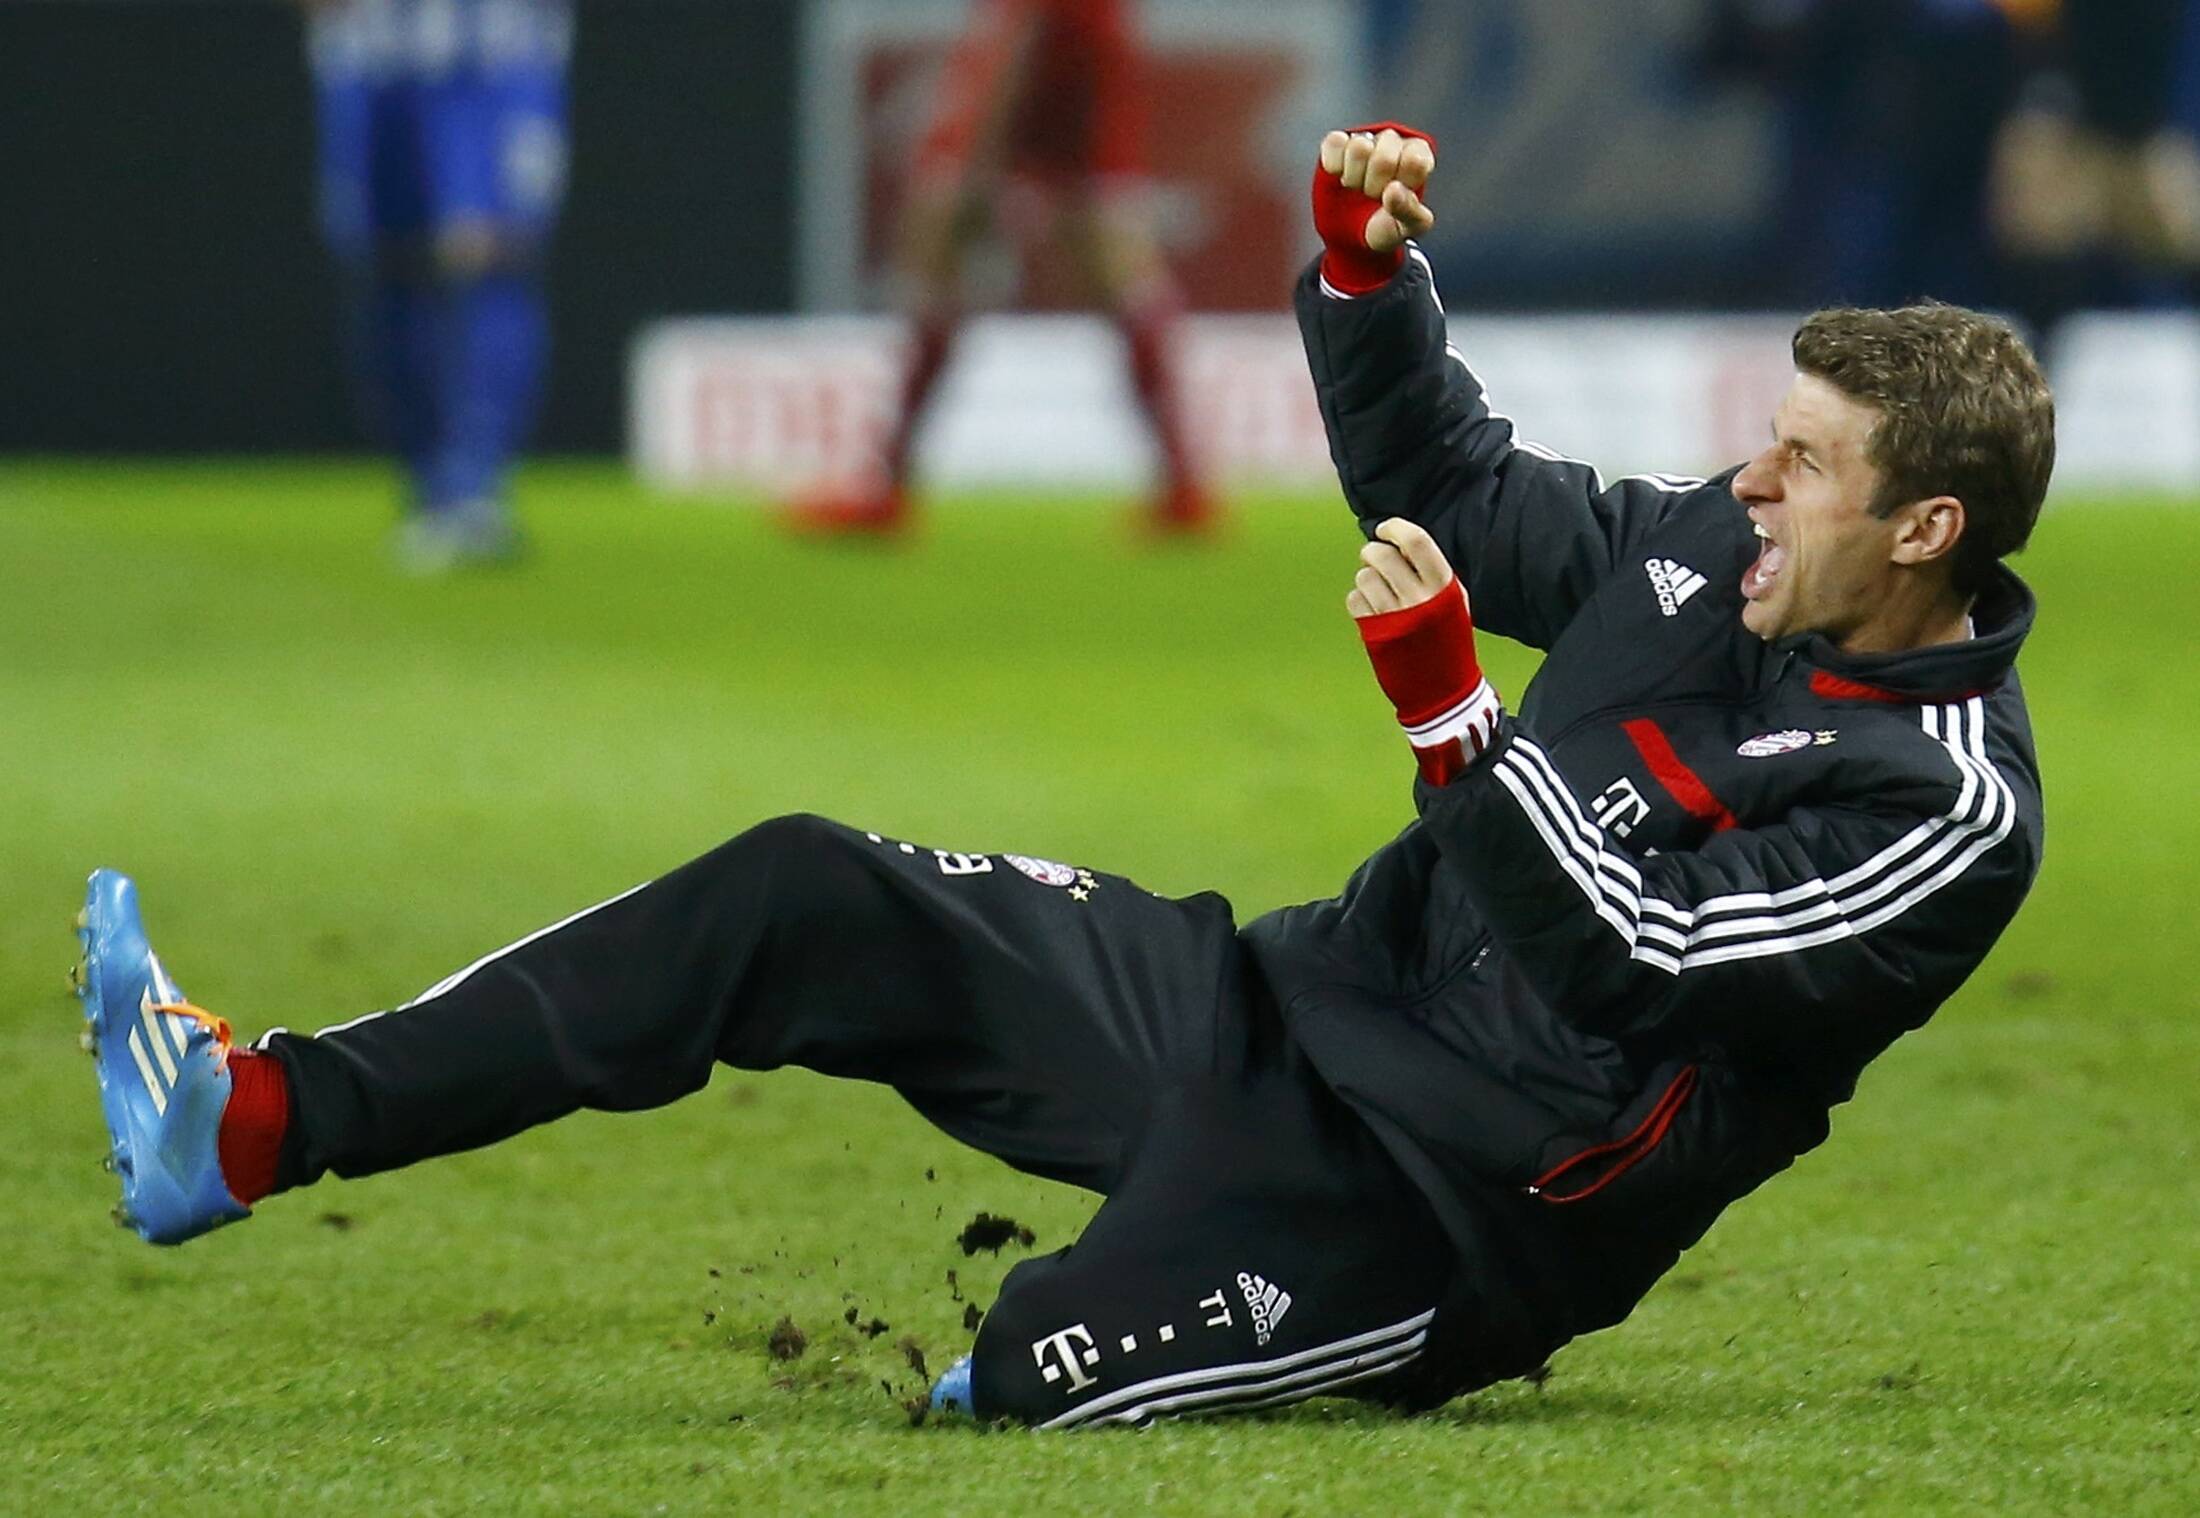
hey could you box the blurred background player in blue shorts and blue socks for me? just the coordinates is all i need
[301,0,572,574]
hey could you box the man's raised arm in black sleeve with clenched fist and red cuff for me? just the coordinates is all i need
[1296,125,1707,649]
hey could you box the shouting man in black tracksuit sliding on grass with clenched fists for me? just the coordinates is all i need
[84,128,2053,1428]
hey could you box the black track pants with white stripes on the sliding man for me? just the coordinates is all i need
[264,816,1450,1423]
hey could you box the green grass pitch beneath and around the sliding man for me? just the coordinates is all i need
[0,464,2200,1518]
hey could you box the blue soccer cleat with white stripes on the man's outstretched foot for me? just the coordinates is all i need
[73,869,251,1243]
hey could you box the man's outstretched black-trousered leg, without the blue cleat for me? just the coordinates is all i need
[262,816,1241,1188]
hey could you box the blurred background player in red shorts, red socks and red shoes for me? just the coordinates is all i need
[790,0,1214,532]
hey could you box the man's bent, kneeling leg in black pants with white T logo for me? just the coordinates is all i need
[970,1038,1452,1428]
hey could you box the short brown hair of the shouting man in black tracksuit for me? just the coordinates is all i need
[1795,301,2055,592]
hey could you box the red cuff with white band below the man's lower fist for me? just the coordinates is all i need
[1357,576,1505,785]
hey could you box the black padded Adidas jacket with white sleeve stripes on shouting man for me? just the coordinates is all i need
[1245,251,2042,1384]
